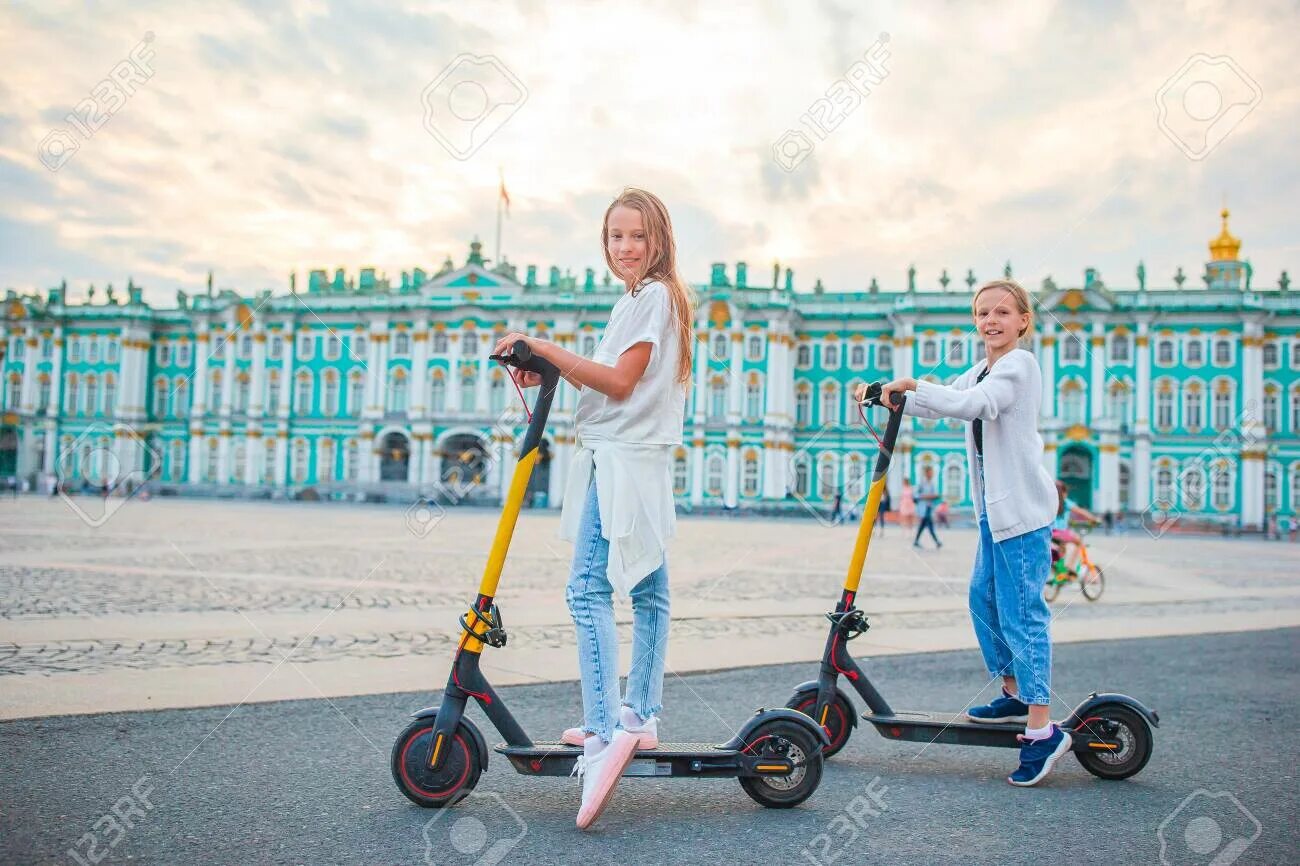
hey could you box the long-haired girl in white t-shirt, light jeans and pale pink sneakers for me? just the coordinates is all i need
[495,189,694,828]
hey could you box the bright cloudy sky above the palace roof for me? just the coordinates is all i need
[0,0,1300,302]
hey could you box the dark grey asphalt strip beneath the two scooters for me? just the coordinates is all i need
[0,629,1300,866]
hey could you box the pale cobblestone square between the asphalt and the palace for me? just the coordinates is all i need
[0,497,1300,716]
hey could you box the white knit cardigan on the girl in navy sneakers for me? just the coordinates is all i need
[904,348,1058,541]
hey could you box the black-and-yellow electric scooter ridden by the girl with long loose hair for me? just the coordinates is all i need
[391,342,828,809]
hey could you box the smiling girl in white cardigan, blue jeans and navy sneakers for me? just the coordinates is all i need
[858,280,1071,787]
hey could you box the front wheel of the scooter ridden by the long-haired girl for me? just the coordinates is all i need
[393,716,484,809]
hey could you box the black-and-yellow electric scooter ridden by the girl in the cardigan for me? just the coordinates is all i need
[787,382,1160,779]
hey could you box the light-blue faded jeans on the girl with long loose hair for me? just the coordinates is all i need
[564,477,670,742]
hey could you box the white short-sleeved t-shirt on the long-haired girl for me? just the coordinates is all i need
[573,281,686,445]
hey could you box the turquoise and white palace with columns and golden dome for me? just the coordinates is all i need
[0,211,1300,528]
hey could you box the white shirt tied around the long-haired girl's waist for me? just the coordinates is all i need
[560,440,677,596]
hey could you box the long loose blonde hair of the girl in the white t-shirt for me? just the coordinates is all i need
[601,186,696,382]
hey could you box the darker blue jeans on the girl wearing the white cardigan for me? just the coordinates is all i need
[970,452,1052,705]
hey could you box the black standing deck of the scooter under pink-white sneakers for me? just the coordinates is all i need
[497,742,794,779]
